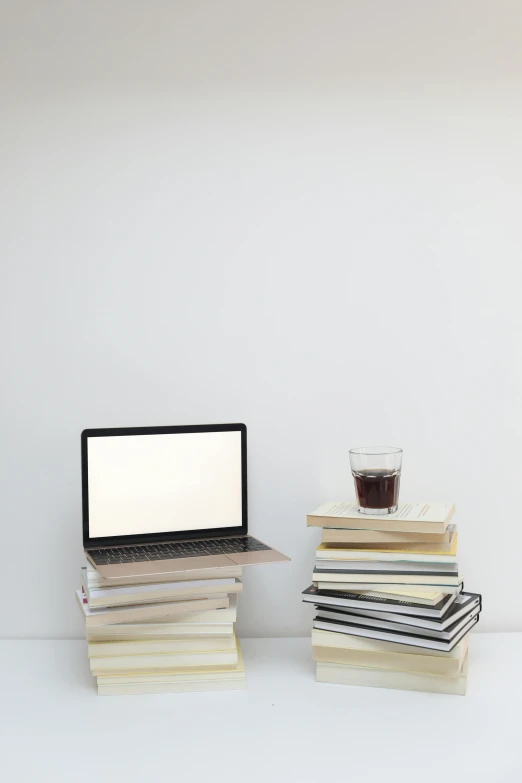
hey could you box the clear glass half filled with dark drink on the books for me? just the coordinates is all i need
[350,446,402,515]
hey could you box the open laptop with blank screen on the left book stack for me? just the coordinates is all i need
[81,424,290,580]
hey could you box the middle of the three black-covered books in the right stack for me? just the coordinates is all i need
[315,596,481,641]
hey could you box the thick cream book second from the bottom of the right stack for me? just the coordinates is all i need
[312,635,469,677]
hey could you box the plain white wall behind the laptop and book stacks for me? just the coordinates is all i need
[0,0,522,637]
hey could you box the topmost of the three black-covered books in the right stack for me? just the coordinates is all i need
[303,585,459,618]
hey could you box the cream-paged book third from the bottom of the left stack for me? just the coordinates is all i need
[87,633,236,658]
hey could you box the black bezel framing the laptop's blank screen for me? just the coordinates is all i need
[81,424,248,549]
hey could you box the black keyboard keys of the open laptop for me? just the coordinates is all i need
[89,536,270,565]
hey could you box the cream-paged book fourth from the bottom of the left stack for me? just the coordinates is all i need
[85,623,234,642]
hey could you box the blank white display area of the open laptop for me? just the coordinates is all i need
[87,432,242,538]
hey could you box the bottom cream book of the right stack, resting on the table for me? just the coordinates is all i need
[316,657,468,696]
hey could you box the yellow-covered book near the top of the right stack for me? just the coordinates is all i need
[315,533,458,563]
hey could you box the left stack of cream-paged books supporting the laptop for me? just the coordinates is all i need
[76,563,246,695]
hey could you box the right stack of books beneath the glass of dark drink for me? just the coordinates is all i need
[303,503,482,695]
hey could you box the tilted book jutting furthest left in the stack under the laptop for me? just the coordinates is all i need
[76,590,229,627]
